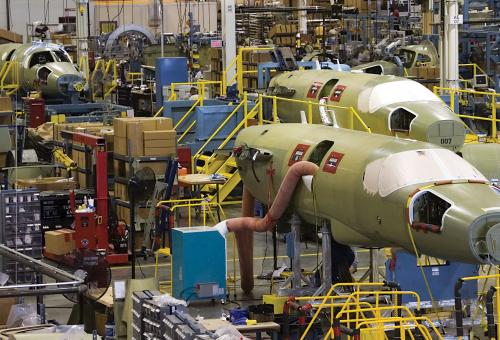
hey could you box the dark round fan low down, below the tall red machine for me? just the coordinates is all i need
[64,249,111,303]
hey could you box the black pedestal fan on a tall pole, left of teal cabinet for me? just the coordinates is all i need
[128,167,156,279]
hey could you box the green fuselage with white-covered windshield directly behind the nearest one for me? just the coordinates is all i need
[268,70,500,181]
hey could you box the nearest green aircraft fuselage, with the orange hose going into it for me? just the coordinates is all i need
[235,124,500,264]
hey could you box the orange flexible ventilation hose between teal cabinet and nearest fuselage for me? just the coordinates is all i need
[216,161,318,293]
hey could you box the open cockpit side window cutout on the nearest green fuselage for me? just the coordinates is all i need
[410,191,451,231]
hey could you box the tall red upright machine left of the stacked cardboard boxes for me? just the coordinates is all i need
[45,133,128,264]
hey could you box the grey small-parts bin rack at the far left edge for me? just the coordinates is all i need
[0,189,43,284]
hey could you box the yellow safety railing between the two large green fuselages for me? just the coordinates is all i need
[259,95,371,132]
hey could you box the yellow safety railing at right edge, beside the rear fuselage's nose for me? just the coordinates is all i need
[433,86,500,141]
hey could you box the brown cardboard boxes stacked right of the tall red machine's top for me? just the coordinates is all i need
[113,118,177,157]
